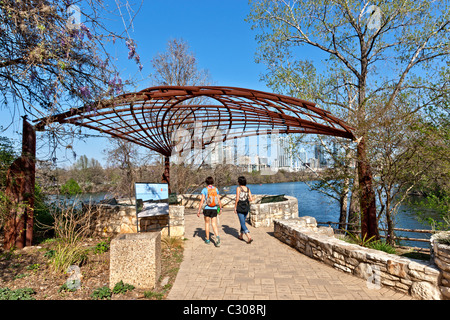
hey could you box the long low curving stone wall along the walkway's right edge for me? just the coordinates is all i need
[274,217,448,300]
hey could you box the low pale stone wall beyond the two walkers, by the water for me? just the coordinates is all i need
[178,194,298,228]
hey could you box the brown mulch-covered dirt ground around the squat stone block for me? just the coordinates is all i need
[0,235,183,300]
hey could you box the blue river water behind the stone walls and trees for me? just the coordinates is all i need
[51,182,431,248]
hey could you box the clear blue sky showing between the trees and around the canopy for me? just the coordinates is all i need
[0,0,320,166]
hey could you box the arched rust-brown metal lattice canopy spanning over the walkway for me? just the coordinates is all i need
[35,86,355,157]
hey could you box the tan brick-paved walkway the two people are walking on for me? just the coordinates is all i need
[168,210,412,300]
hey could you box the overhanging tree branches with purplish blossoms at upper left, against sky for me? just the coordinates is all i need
[0,0,142,141]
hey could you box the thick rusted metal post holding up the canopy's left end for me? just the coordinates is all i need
[4,116,36,250]
